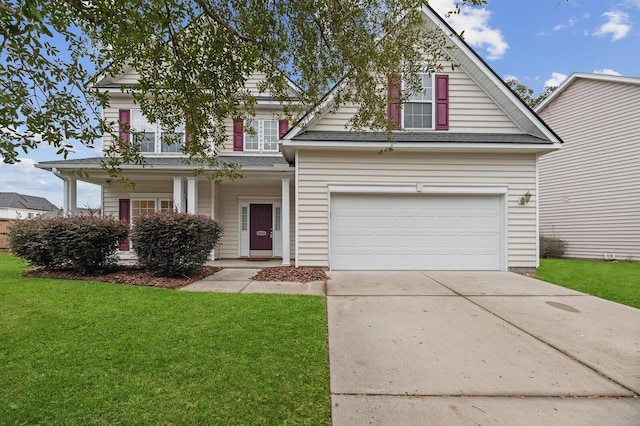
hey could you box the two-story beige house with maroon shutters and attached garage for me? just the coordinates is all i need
[38,7,561,270]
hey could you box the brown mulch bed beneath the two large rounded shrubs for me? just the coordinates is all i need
[22,266,223,289]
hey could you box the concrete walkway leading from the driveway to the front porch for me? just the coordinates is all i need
[181,267,326,295]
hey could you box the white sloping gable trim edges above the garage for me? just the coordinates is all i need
[283,5,562,145]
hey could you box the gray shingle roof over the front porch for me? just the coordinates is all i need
[38,155,289,170]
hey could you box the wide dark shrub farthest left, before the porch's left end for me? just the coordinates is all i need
[9,215,128,275]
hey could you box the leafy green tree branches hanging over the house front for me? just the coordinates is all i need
[0,0,486,175]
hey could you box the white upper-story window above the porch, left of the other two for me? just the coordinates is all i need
[130,109,185,153]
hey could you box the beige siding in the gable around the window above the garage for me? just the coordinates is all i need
[309,64,522,133]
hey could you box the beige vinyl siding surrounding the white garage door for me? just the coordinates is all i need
[297,151,537,268]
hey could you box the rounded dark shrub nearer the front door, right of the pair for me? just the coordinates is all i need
[131,211,222,277]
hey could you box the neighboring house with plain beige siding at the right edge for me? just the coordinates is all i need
[536,73,640,261]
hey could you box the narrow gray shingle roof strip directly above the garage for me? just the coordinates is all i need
[293,130,552,144]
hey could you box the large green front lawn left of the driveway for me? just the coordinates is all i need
[0,254,331,425]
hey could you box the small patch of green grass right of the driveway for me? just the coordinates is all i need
[538,259,640,309]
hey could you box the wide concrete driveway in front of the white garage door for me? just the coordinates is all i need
[327,271,640,426]
